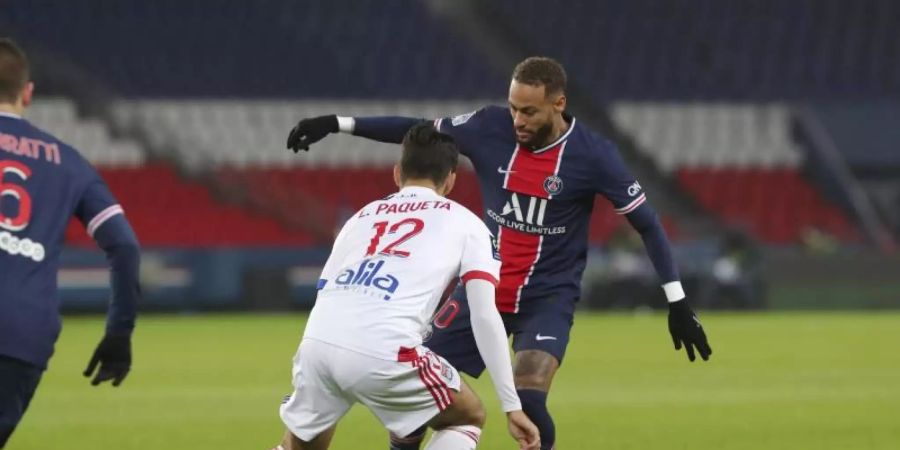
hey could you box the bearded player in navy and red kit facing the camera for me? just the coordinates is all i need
[287,57,712,450]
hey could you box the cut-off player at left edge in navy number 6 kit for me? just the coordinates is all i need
[0,39,140,448]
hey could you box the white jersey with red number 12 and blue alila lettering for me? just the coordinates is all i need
[304,186,500,361]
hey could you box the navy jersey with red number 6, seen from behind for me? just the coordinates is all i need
[0,114,122,367]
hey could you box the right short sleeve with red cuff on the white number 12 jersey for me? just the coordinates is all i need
[459,215,500,286]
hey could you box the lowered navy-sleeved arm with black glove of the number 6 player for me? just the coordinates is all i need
[84,214,141,386]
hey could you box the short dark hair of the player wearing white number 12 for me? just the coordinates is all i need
[400,123,459,185]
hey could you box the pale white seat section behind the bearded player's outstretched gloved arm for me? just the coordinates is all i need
[115,99,491,167]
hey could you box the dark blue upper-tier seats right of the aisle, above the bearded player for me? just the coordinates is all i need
[491,0,900,101]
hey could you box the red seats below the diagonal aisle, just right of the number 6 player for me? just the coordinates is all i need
[66,165,312,247]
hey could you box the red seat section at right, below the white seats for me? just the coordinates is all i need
[678,168,858,244]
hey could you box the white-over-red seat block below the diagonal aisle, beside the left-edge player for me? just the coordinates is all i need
[27,98,312,247]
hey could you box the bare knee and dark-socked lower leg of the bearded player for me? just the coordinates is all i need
[513,350,559,450]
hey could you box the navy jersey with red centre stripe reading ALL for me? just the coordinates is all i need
[435,106,646,313]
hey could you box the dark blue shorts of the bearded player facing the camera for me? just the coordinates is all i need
[425,286,575,378]
